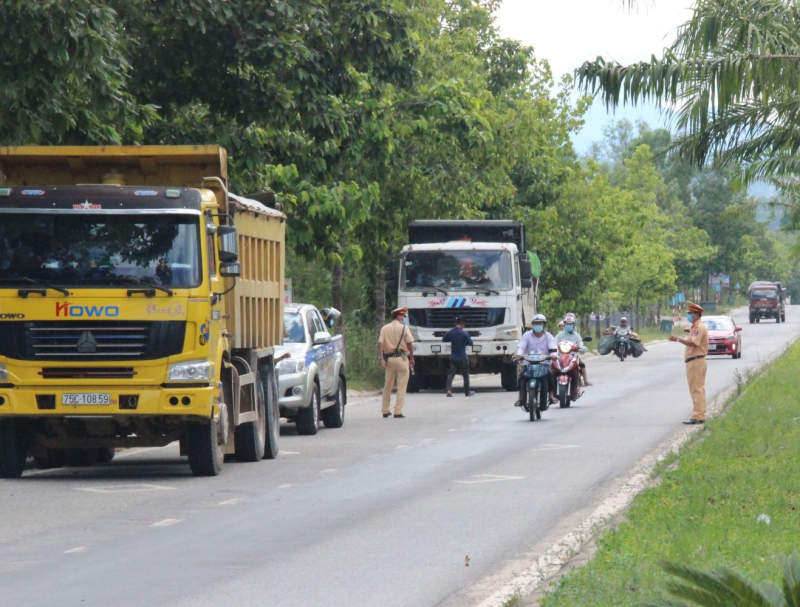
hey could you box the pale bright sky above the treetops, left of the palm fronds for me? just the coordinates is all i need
[497,0,692,154]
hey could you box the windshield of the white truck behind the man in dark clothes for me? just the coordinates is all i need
[400,251,514,292]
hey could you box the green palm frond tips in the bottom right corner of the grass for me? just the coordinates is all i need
[648,552,800,607]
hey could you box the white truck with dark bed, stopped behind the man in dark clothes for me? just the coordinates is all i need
[397,221,536,392]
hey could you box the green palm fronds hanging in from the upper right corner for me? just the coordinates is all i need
[576,0,800,181]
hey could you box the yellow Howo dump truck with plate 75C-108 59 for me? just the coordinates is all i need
[0,146,286,478]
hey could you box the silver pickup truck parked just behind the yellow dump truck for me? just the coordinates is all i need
[275,304,347,434]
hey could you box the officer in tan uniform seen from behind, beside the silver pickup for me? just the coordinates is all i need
[378,308,414,417]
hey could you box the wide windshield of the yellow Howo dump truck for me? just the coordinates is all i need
[0,213,202,287]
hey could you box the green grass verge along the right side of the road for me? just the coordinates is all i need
[541,345,800,607]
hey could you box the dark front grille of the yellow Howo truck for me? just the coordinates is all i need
[0,321,186,362]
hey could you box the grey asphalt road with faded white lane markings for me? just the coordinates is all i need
[0,306,800,607]
